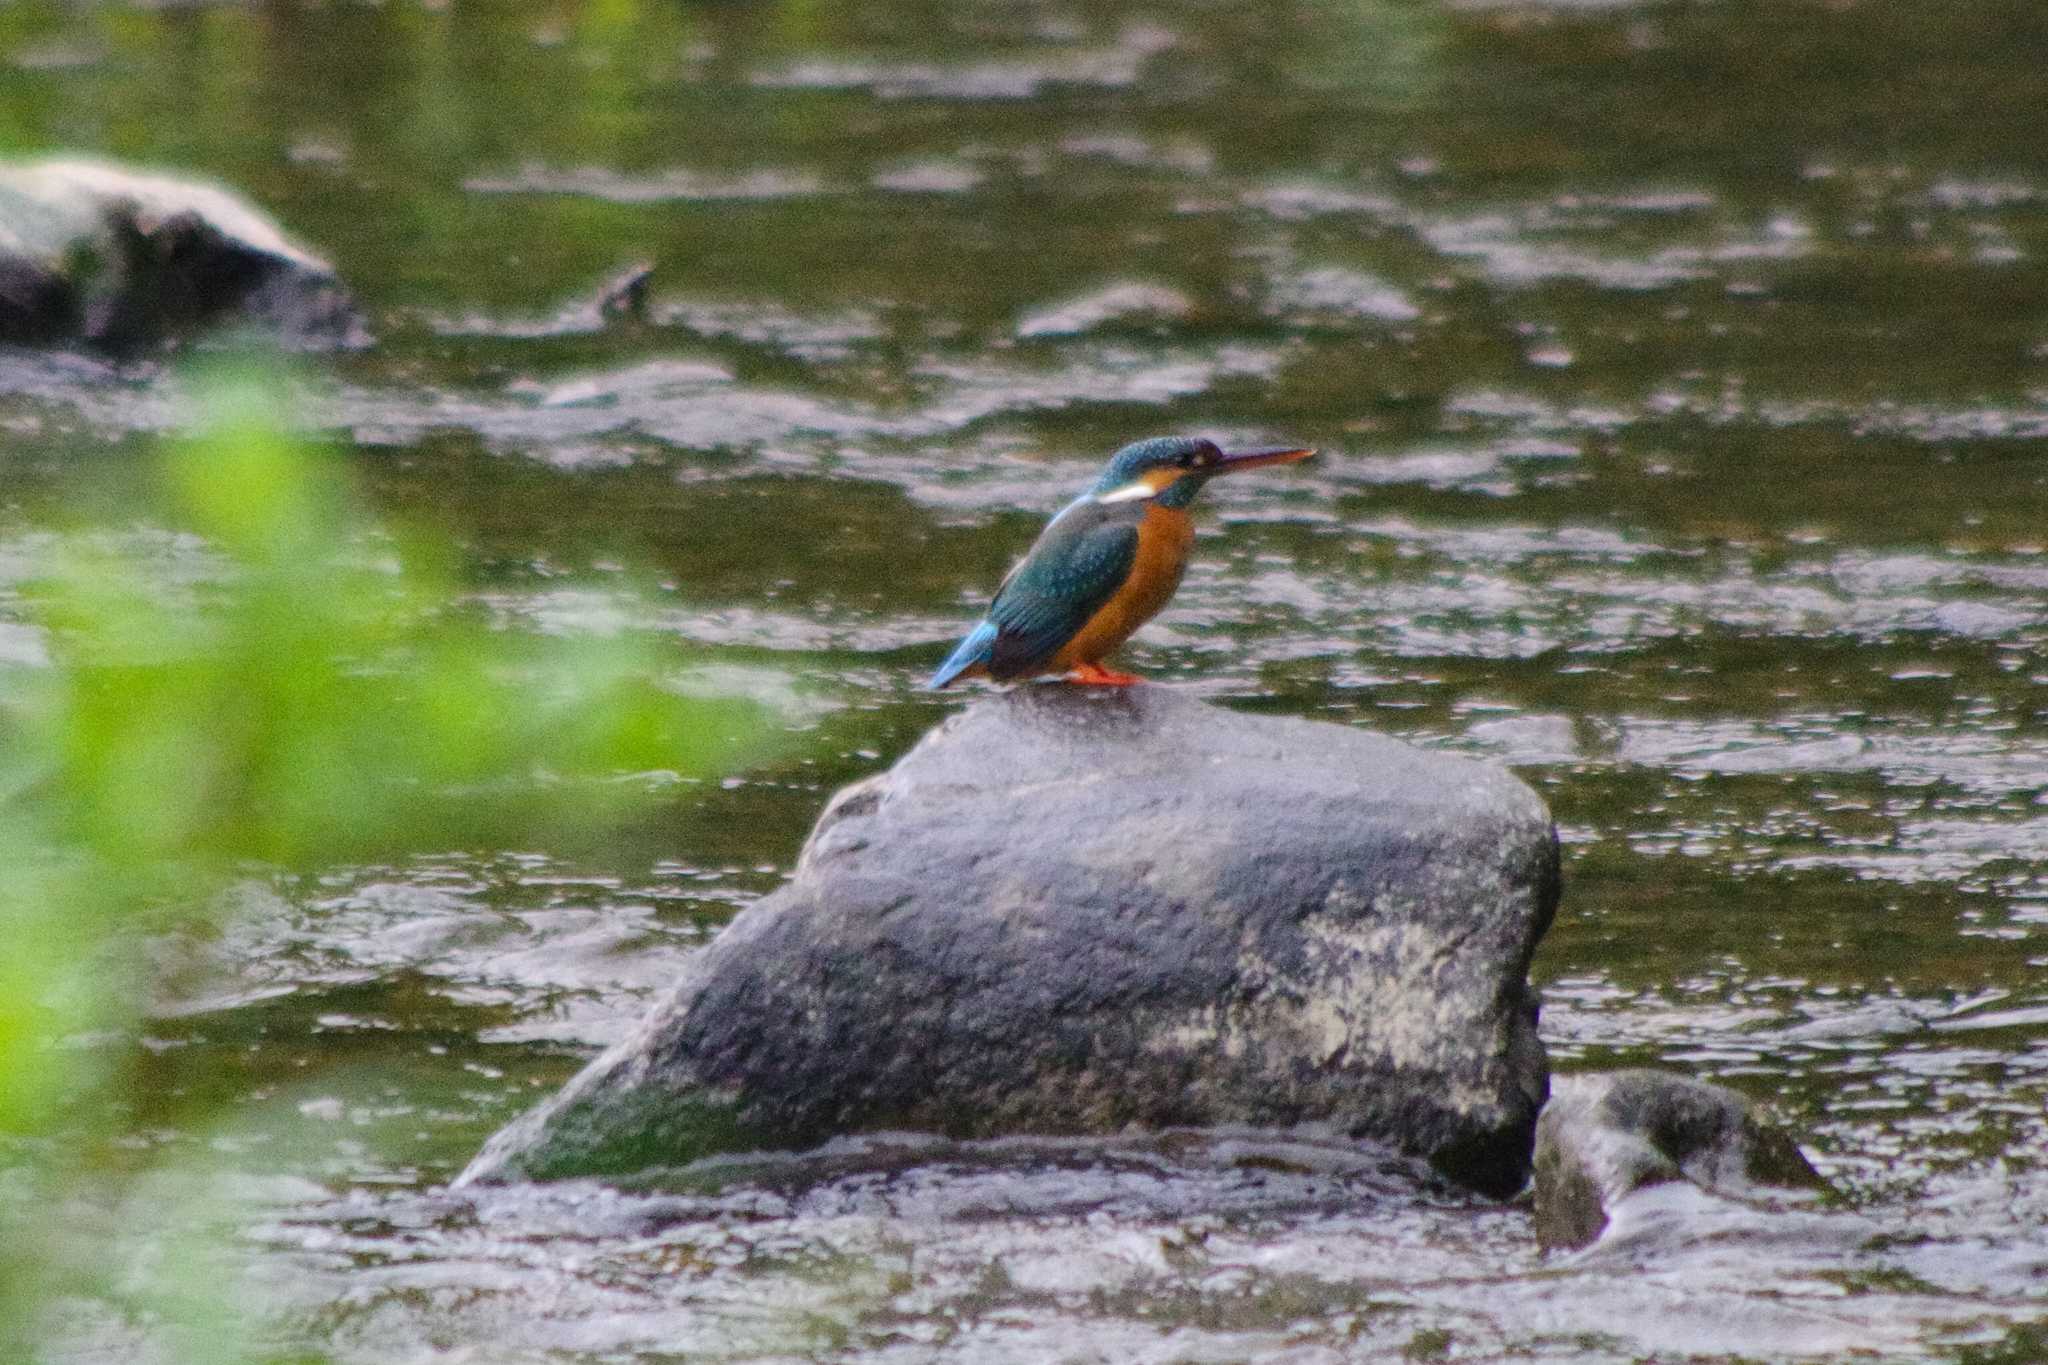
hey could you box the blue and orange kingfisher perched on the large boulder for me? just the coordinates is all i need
[926,436,1315,688]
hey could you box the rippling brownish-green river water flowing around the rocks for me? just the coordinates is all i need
[0,0,2048,1365]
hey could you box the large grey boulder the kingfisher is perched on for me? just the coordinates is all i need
[463,686,1559,1193]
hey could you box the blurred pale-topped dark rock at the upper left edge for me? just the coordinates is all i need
[0,160,369,354]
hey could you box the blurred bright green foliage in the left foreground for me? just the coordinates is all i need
[0,387,766,1361]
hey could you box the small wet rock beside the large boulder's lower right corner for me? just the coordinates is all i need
[1536,1070,1827,1248]
